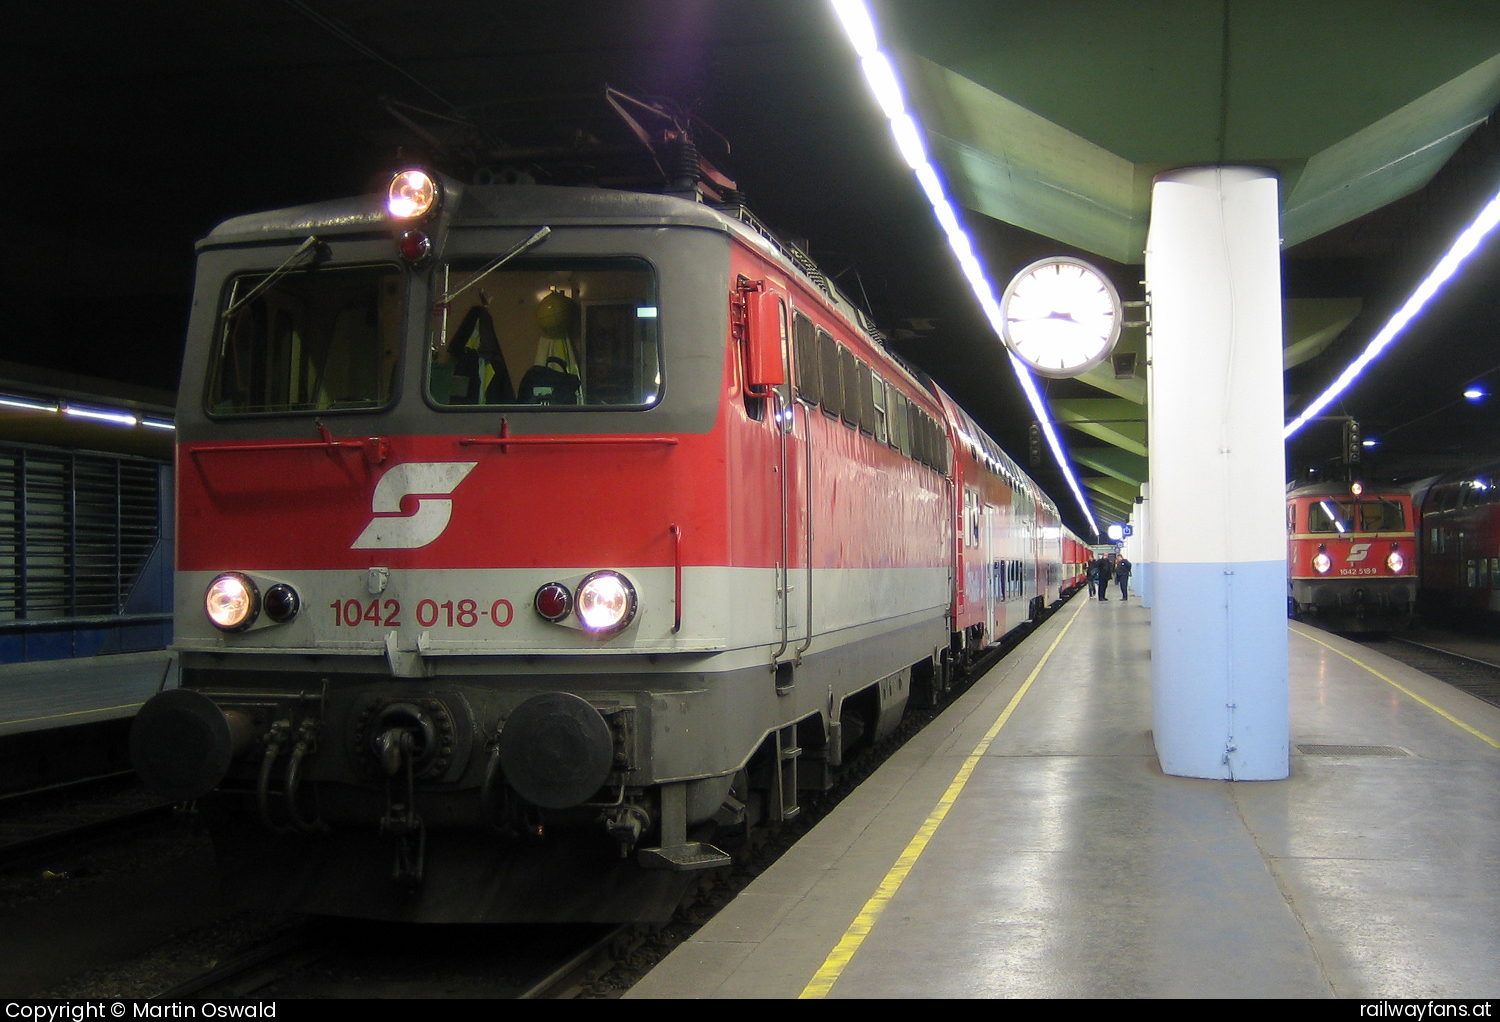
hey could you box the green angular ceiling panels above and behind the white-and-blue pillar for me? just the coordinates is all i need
[876,0,1500,516]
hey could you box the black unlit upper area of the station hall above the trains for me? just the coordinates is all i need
[0,0,1500,534]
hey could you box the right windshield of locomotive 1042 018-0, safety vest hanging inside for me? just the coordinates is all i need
[428,258,663,410]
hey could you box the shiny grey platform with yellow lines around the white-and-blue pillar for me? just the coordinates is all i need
[626,594,1500,998]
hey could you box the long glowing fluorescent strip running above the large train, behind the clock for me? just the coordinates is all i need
[830,0,1100,536]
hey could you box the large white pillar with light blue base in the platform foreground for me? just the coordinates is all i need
[1146,167,1290,780]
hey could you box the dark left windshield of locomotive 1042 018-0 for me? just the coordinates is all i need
[206,266,402,416]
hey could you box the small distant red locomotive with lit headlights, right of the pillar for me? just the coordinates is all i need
[1287,483,1416,632]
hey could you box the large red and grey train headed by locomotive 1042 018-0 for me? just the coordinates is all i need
[132,171,1070,921]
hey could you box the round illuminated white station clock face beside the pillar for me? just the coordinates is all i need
[1001,255,1121,377]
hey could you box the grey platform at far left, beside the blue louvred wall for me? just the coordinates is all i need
[0,650,177,737]
